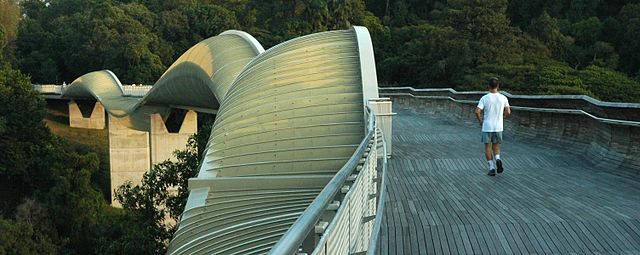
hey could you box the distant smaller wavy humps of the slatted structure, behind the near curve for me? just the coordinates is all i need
[62,30,264,131]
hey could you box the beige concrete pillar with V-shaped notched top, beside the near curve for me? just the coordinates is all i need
[151,110,198,164]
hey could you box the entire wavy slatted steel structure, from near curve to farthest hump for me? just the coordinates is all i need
[63,27,378,254]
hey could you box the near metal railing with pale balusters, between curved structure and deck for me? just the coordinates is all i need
[268,107,386,255]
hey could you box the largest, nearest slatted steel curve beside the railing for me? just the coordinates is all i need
[169,26,377,254]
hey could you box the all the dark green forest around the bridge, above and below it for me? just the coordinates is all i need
[0,0,640,254]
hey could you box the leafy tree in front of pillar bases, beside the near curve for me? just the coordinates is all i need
[106,136,201,254]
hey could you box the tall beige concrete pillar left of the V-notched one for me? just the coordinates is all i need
[109,115,151,207]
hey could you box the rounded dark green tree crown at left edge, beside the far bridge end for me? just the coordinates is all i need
[0,63,51,209]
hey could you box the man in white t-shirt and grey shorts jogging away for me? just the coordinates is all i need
[476,77,511,176]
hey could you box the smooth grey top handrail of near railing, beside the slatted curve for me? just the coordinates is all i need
[267,106,375,255]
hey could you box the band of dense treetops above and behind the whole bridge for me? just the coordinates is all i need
[5,0,640,101]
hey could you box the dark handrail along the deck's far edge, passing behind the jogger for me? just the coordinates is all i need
[383,93,640,127]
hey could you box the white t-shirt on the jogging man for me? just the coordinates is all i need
[478,93,509,132]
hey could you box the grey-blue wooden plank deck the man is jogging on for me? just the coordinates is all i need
[378,112,640,254]
